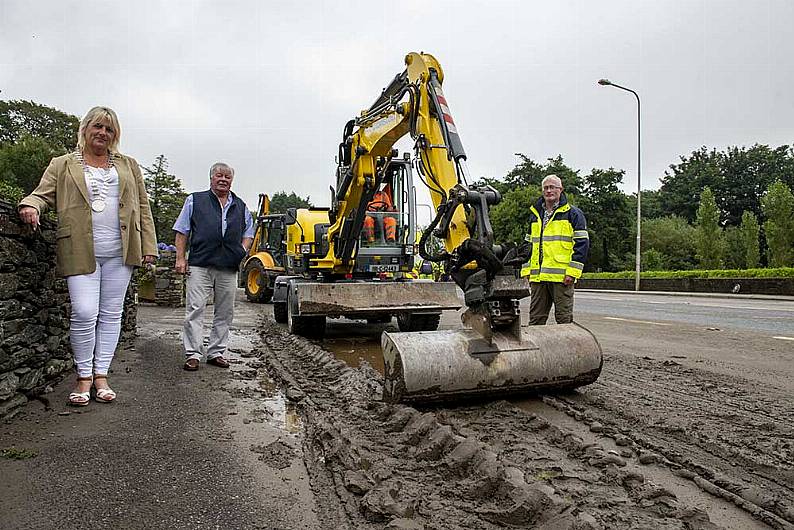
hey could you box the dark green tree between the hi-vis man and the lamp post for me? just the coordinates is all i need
[579,168,631,271]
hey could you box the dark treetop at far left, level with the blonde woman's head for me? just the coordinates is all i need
[0,101,80,151]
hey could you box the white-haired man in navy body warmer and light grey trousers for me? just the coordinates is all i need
[174,162,254,371]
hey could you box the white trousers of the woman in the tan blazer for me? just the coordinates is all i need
[66,256,132,377]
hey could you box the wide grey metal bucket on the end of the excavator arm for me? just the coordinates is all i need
[381,324,603,403]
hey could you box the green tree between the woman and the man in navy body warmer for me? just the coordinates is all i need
[141,155,187,244]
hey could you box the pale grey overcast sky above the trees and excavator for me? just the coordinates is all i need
[0,0,794,217]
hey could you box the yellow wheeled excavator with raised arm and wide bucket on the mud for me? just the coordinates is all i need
[273,53,603,402]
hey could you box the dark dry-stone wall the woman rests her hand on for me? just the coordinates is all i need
[0,200,137,419]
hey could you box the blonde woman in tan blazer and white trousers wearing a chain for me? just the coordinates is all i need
[19,107,157,406]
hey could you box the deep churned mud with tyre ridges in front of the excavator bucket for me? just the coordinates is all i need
[252,318,791,529]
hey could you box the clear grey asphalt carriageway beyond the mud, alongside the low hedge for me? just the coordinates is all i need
[574,291,794,336]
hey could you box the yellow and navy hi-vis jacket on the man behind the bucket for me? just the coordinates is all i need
[521,194,590,283]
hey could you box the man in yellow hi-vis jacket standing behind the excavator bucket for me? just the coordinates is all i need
[521,175,590,325]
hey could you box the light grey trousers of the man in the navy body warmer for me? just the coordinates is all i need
[182,266,237,360]
